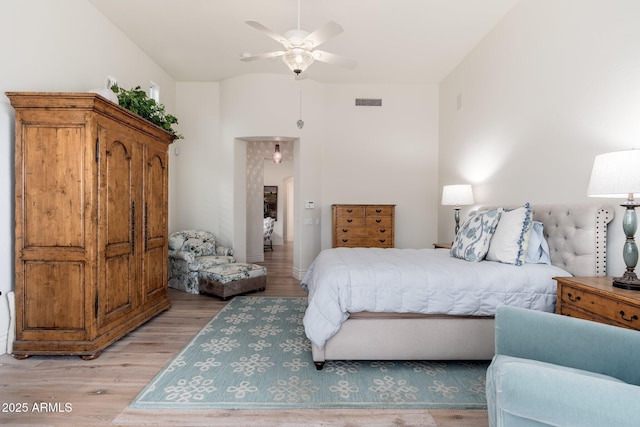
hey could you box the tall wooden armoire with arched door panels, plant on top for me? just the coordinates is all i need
[6,92,173,359]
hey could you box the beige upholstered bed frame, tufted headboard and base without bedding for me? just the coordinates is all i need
[312,205,614,370]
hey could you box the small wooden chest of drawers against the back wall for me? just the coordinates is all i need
[331,205,395,248]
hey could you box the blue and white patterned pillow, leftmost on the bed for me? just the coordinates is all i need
[450,208,503,261]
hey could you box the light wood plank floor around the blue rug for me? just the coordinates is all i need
[0,245,488,427]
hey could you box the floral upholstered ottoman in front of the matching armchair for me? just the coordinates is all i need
[198,263,267,300]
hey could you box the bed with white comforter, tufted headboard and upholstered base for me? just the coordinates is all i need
[302,205,614,369]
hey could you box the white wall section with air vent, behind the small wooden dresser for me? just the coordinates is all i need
[322,84,438,248]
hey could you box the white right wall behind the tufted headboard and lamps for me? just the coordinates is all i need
[438,0,640,274]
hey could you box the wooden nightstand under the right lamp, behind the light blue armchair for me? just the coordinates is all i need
[554,277,640,330]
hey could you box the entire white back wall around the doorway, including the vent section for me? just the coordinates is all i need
[174,74,438,274]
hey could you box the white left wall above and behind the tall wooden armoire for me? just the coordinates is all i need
[0,0,175,352]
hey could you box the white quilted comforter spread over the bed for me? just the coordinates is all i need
[302,248,571,348]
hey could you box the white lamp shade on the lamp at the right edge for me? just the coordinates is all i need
[587,150,640,198]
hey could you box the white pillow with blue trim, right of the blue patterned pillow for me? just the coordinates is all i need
[487,203,531,265]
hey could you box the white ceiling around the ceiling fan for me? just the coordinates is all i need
[89,0,518,83]
